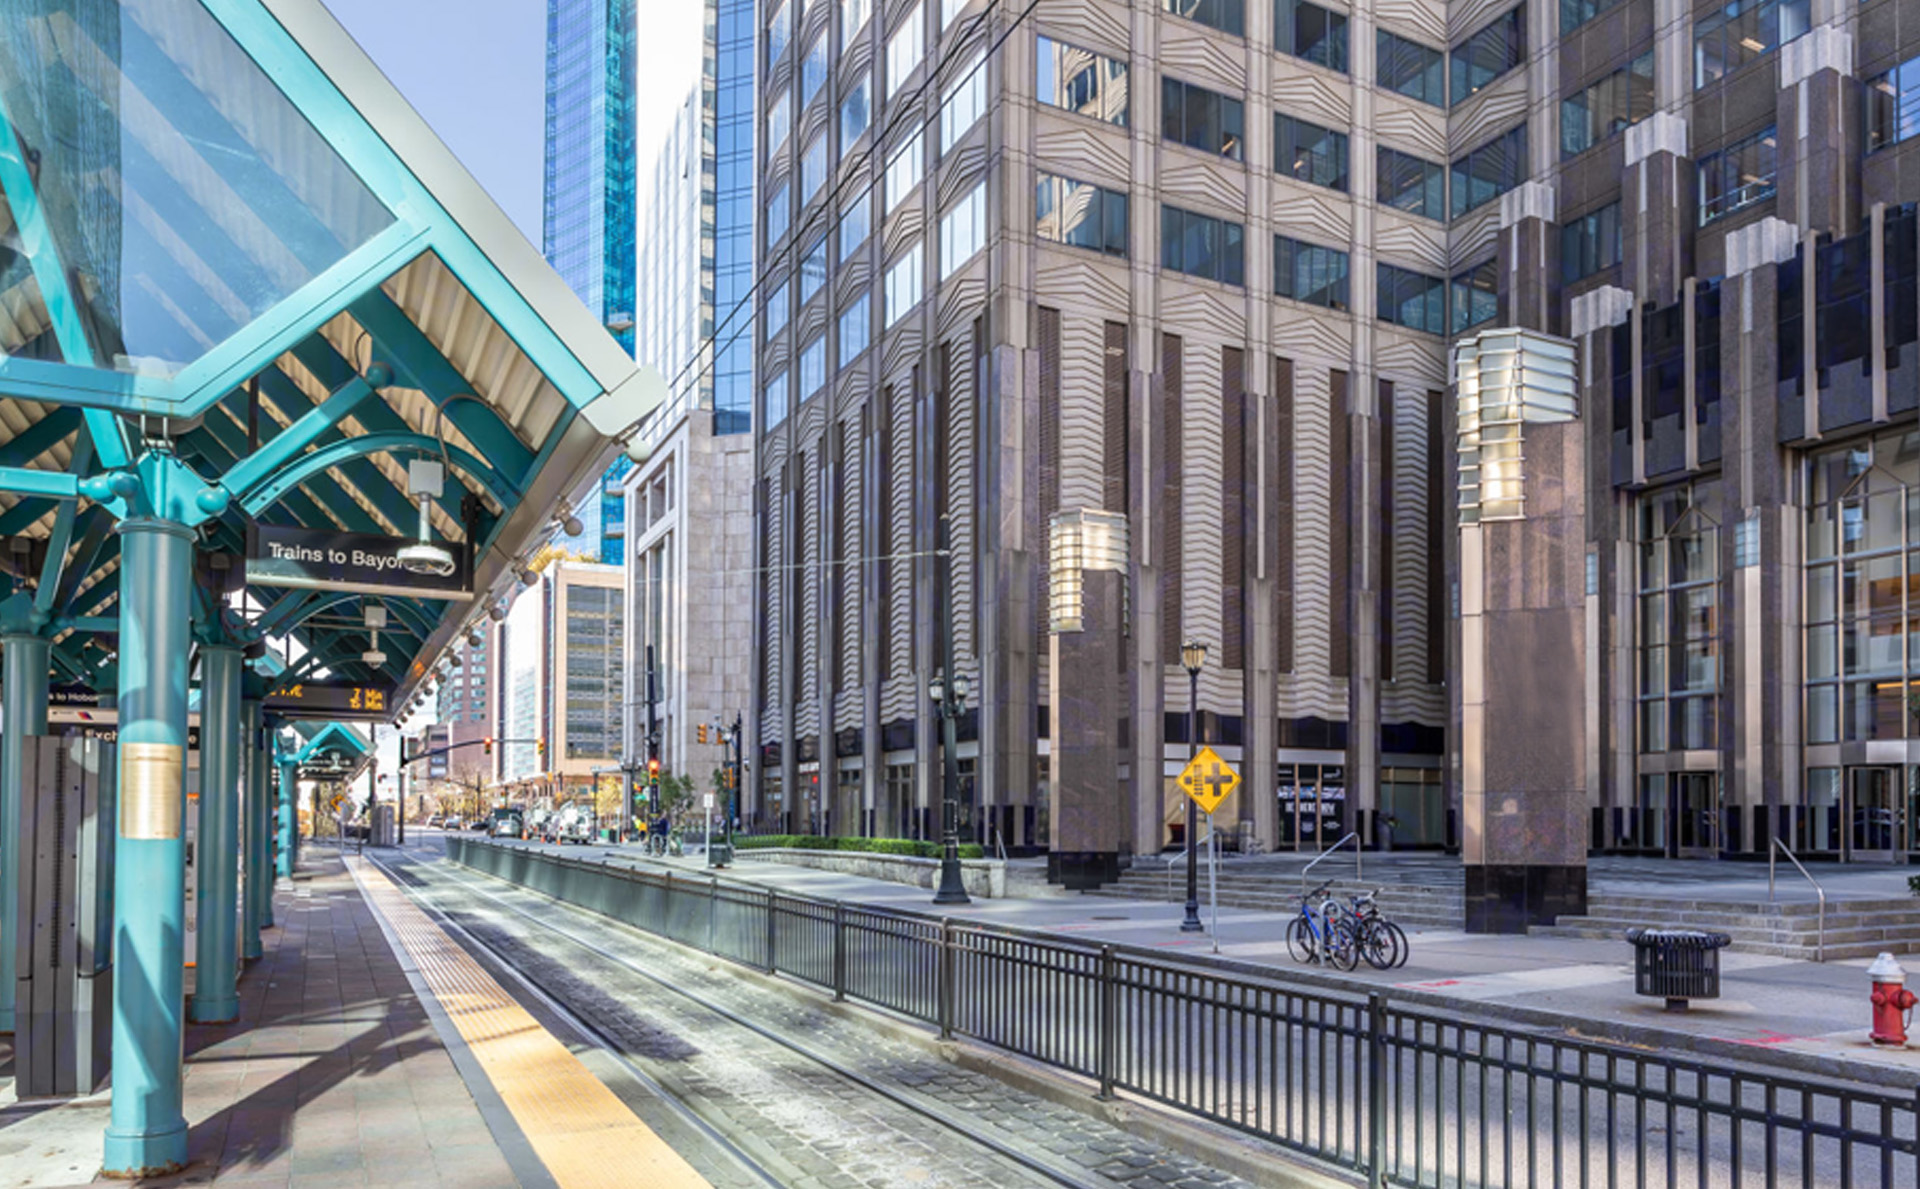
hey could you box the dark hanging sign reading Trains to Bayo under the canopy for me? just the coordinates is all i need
[246,524,472,599]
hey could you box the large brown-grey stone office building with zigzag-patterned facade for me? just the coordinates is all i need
[749,0,1920,868]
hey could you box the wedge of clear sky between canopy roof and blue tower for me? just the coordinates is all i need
[324,0,547,246]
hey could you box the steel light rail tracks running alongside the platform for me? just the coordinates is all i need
[369,855,1119,1189]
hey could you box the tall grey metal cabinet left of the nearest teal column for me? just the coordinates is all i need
[8,736,119,1099]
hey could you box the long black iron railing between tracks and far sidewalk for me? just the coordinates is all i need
[447,837,1920,1189]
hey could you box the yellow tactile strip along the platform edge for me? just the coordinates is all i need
[349,862,707,1189]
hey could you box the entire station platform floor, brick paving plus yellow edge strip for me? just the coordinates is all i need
[0,847,707,1189]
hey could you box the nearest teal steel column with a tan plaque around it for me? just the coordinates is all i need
[102,517,194,1176]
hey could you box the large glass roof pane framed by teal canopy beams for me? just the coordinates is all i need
[0,0,394,376]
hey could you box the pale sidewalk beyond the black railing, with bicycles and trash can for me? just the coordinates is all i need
[510,845,1920,1089]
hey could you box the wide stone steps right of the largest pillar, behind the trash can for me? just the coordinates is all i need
[1536,893,1920,960]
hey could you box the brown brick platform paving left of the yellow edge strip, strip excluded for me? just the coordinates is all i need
[0,847,551,1189]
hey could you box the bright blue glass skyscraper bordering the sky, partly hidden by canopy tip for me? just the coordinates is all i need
[541,0,637,565]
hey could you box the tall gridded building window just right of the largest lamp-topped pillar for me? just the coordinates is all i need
[1638,482,1720,753]
